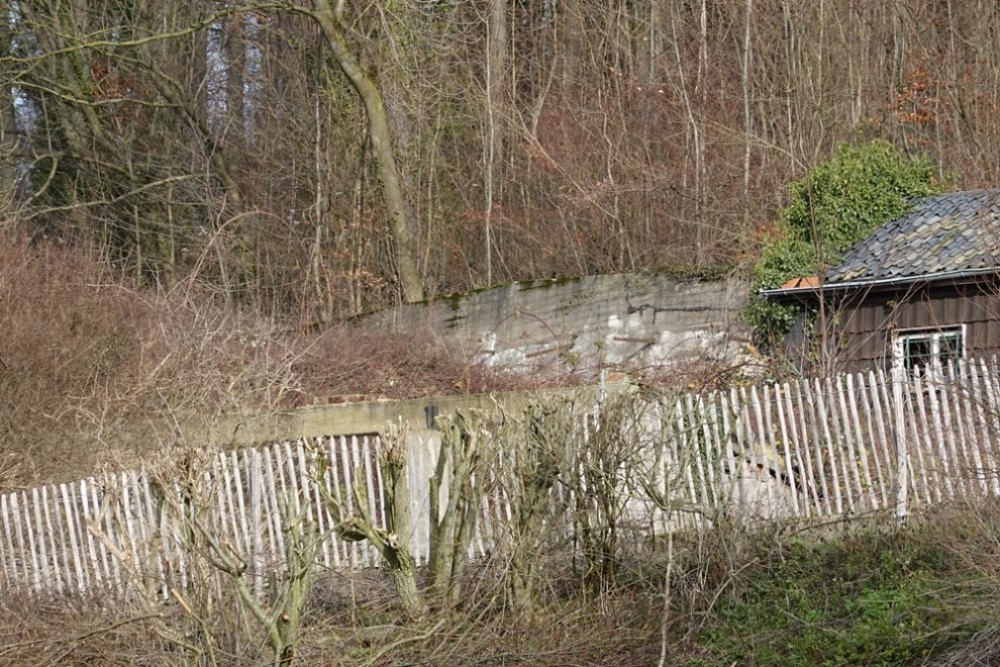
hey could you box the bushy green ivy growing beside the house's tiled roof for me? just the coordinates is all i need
[744,140,942,350]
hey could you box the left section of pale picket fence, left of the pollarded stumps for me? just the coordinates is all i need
[0,437,454,593]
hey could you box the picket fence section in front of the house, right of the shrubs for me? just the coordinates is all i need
[668,361,1000,518]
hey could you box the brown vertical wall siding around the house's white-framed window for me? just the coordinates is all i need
[831,285,1000,371]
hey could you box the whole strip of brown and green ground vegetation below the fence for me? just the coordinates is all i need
[0,502,1000,667]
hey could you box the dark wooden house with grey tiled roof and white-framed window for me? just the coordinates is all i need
[761,190,1000,373]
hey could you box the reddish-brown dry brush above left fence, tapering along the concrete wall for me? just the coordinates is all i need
[0,234,580,489]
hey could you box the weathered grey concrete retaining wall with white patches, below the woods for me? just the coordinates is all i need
[369,273,749,371]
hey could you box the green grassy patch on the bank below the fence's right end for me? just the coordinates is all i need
[687,531,986,667]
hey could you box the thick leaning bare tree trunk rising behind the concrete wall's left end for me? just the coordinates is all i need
[313,0,424,303]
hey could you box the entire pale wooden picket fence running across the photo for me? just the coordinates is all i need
[0,362,1000,593]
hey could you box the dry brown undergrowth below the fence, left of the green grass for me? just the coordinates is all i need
[0,573,659,667]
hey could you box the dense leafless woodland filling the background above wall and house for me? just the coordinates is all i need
[0,0,1000,324]
